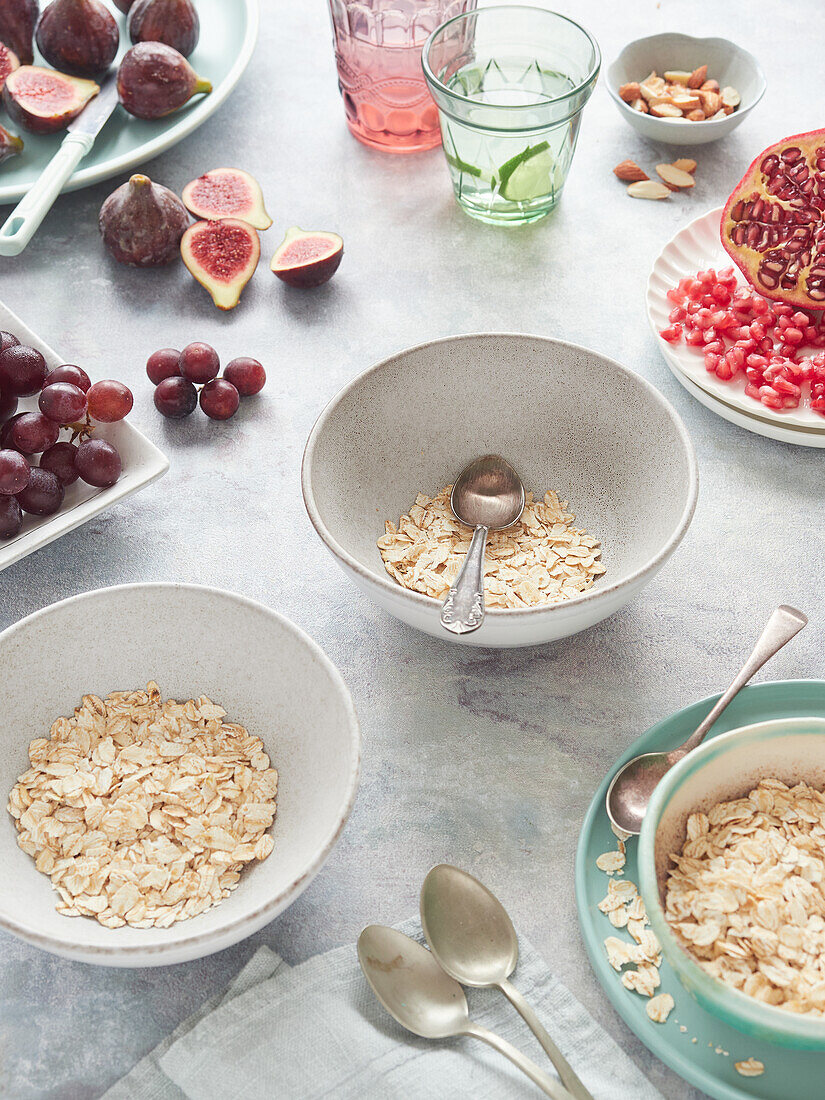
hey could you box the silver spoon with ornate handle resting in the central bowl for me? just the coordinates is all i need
[441,454,525,634]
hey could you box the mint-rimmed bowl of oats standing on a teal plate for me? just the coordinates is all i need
[638,717,825,1051]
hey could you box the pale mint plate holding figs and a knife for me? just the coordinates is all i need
[0,0,259,205]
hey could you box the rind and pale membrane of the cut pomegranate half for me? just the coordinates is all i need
[719,130,825,309]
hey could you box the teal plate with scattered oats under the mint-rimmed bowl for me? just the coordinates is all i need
[575,680,825,1100]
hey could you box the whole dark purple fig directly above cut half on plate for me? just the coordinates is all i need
[35,0,120,77]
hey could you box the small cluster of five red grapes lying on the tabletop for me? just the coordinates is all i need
[146,341,266,420]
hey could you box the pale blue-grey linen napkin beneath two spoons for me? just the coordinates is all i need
[103,920,662,1100]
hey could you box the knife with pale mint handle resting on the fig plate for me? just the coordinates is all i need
[0,74,118,256]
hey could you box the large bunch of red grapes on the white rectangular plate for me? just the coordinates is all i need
[0,332,133,539]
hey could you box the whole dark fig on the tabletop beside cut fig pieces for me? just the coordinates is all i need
[99,175,189,267]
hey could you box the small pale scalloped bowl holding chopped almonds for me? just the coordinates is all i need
[606,33,766,145]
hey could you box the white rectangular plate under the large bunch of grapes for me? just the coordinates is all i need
[0,301,169,570]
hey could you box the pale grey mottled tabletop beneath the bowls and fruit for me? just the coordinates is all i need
[0,0,825,1100]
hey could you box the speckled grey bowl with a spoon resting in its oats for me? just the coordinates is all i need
[303,333,697,646]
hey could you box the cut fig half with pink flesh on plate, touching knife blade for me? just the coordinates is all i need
[3,65,100,134]
